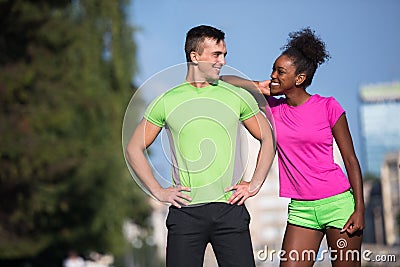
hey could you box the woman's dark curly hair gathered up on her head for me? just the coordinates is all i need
[281,27,330,87]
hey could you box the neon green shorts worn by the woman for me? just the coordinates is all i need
[288,191,355,230]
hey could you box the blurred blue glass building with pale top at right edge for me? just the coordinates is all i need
[359,82,400,176]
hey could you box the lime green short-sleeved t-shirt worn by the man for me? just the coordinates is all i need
[144,81,259,205]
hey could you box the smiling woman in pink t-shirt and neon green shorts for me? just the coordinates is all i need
[221,28,365,266]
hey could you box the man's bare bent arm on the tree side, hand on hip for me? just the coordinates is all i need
[126,119,191,208]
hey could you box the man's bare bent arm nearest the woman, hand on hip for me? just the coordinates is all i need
[226,112,275,205]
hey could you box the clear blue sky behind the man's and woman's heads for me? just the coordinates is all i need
[129,0,400,172]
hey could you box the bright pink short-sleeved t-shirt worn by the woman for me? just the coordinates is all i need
[268,94,350,200]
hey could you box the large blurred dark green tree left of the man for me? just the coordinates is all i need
[0,0,150,266]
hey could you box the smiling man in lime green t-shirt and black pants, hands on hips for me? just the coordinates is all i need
[127,25,275,267]
